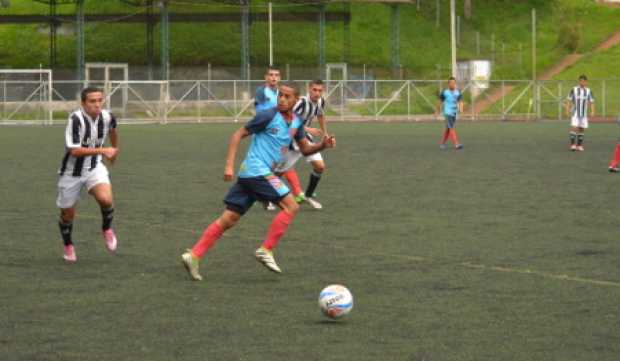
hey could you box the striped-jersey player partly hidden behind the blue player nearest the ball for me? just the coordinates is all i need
[276,80,327,209]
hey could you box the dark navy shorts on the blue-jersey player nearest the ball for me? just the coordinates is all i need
[224,174,290,215]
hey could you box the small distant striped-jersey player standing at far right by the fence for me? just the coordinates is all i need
[566,75,595,152]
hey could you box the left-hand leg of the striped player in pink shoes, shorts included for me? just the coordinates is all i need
[56,176,82,262]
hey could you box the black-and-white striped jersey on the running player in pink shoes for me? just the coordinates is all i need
[59,109,116,177]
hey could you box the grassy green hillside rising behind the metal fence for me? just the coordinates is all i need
[0,0,620,79]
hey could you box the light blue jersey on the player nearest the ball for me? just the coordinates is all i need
[239,108,305,178]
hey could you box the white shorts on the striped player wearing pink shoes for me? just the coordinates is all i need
[56,163,110,209]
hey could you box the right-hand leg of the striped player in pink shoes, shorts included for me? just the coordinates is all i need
[85,164,118,252]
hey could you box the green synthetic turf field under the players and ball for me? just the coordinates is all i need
[0,123,620,361]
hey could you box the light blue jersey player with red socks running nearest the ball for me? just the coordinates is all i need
[181,84,336,281]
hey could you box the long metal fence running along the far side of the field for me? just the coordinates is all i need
[0,79,620,124]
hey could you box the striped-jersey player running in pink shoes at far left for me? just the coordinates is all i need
[56,87,118,262]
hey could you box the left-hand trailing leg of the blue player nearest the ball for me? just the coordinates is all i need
[181,181,255,281]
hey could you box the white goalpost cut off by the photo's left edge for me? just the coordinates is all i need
[0,69,54,124]
